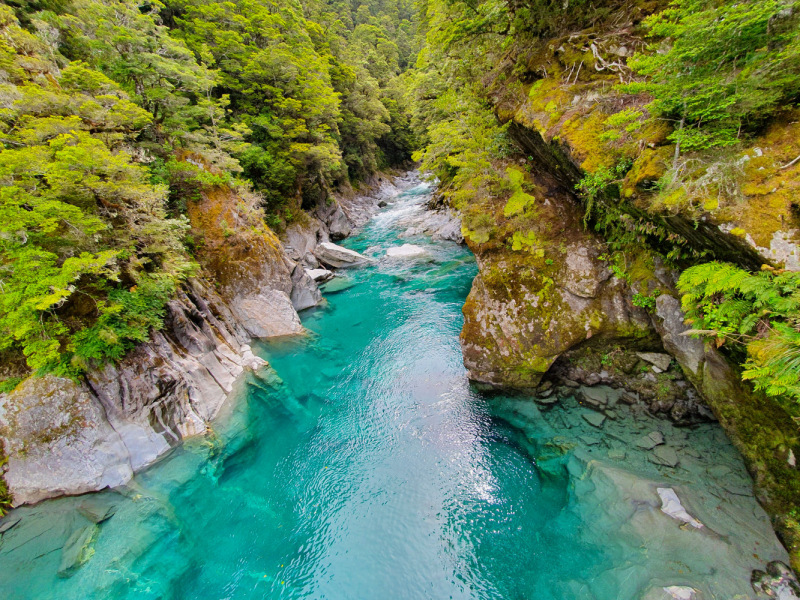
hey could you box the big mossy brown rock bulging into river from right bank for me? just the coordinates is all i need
[461,185,659,387]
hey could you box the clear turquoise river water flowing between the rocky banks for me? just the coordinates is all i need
[0,180,788,600]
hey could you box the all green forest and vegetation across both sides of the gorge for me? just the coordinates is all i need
[0,0,800,422]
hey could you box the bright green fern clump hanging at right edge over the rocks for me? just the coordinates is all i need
[678,262,800,401]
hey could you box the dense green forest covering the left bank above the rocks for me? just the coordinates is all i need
[0,0,416,382]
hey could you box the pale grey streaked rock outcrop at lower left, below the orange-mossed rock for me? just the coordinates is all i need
[0,281,266,505]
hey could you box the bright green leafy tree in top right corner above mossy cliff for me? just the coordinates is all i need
[625,0,800,151]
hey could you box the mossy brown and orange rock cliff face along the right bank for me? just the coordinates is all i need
[461,27,800,568]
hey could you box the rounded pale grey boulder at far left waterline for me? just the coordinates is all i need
[0,375,133,506]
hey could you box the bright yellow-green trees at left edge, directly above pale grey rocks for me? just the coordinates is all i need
[0,7,192,375]
